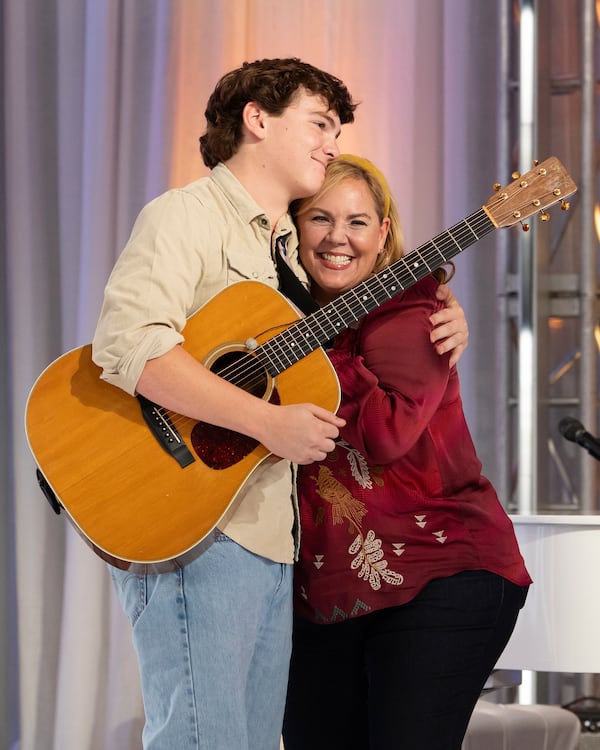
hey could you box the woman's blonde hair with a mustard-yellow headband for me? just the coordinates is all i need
[290,154,454,283]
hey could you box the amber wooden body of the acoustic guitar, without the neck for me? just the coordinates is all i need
[26,281,340,571]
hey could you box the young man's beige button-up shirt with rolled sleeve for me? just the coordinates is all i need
[93,164,306,563]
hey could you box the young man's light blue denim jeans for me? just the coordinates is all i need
[110,532,292,750]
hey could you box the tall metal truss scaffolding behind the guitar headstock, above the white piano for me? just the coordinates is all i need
[498,0,600,513]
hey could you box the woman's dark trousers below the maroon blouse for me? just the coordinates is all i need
[283,570,527,750]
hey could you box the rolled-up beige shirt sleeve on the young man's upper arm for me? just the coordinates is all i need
[92,190,210,395]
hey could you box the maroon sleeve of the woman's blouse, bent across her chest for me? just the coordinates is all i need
[329,280,458,464]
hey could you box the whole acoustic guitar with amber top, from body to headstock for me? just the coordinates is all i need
[26,157,577,571]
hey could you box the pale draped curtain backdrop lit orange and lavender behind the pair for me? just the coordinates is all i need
[0,0,502,750]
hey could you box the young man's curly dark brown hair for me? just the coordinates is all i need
[200,57,357,169]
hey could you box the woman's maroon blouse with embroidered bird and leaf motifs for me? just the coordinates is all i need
[294,277,531,623]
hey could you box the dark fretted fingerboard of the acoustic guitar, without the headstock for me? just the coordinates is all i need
[254,208,496,377]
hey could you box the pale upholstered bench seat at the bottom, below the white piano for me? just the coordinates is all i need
[462,700,581,750]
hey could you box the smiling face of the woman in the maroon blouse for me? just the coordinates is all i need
[297,178,389,304]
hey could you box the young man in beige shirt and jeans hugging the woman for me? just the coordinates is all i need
[93,59,466,750]
